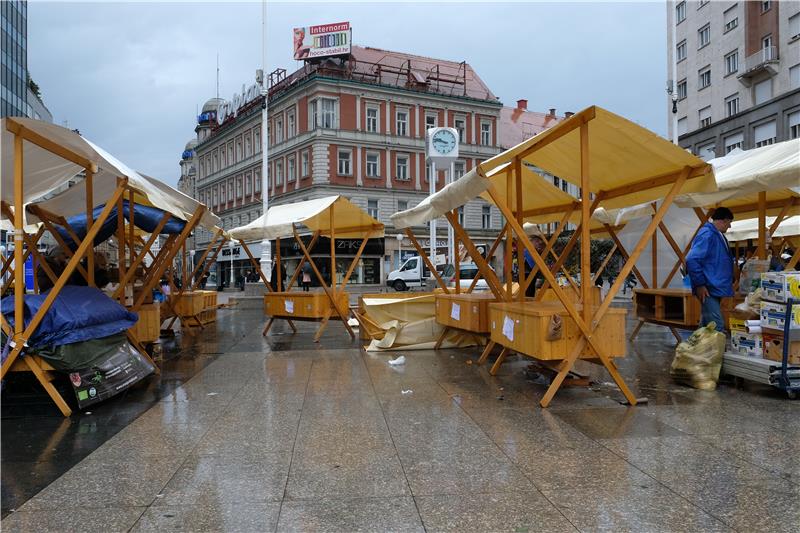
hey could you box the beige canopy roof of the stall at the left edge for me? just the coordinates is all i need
[0,117,220,228]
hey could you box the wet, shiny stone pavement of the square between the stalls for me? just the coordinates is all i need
[2,308,800,532]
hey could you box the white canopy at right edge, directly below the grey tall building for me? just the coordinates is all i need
[675,139,800,207]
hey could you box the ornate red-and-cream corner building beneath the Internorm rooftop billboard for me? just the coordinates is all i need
[182,46,559,285]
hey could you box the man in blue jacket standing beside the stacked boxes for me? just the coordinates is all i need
[686,207,733,331]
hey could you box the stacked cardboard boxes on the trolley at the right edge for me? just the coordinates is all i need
[728,271,800,364]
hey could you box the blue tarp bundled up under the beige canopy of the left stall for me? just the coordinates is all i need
[56,200,186,250]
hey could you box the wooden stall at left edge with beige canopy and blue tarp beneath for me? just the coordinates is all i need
[0,118,218,416]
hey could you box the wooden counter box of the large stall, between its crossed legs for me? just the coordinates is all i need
[489,302,627,361]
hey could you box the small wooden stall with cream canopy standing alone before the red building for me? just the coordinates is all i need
[230,195,383,342]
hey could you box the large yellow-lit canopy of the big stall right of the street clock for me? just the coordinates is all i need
[391,106,716,229]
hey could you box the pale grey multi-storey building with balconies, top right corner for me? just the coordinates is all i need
[667,0,800,160]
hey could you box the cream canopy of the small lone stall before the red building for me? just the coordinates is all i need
[229,195,383,240]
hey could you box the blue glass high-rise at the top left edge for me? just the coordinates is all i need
[0,0,29,117]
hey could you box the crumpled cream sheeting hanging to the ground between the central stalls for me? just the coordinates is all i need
[362,293,474,352]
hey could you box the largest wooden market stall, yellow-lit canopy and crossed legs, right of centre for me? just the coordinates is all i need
[392,107,716,407]
